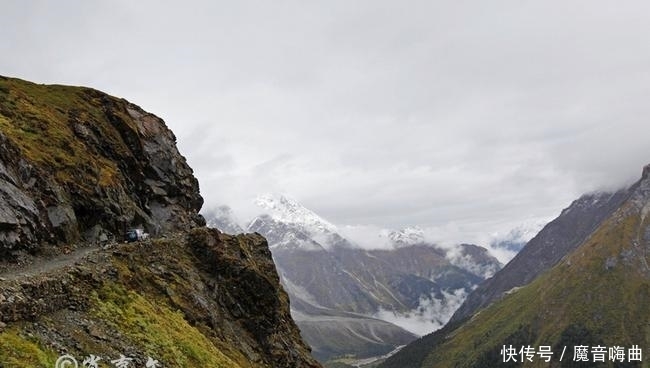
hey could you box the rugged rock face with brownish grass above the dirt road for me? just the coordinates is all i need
[0,77,204,257]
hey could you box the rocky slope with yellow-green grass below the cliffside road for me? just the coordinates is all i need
[0,228,319,368]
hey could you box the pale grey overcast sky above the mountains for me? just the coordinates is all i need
[0,0,650,246]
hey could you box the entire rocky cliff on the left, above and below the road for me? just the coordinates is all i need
[0,78,319,368]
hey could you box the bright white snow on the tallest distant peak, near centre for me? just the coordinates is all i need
[255,194,338,233]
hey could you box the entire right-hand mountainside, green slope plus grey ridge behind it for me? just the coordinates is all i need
[381,165,650,368]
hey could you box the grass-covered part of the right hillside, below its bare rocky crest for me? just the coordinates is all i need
[416,203,650,367]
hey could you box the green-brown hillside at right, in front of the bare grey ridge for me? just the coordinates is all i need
[383,166,650,367]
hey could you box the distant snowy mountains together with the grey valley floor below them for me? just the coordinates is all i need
[205,195,501,361]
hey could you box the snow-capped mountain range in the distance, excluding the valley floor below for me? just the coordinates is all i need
[247,194,501,315]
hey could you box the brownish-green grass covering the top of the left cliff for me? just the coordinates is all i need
[0,77,136,192]
